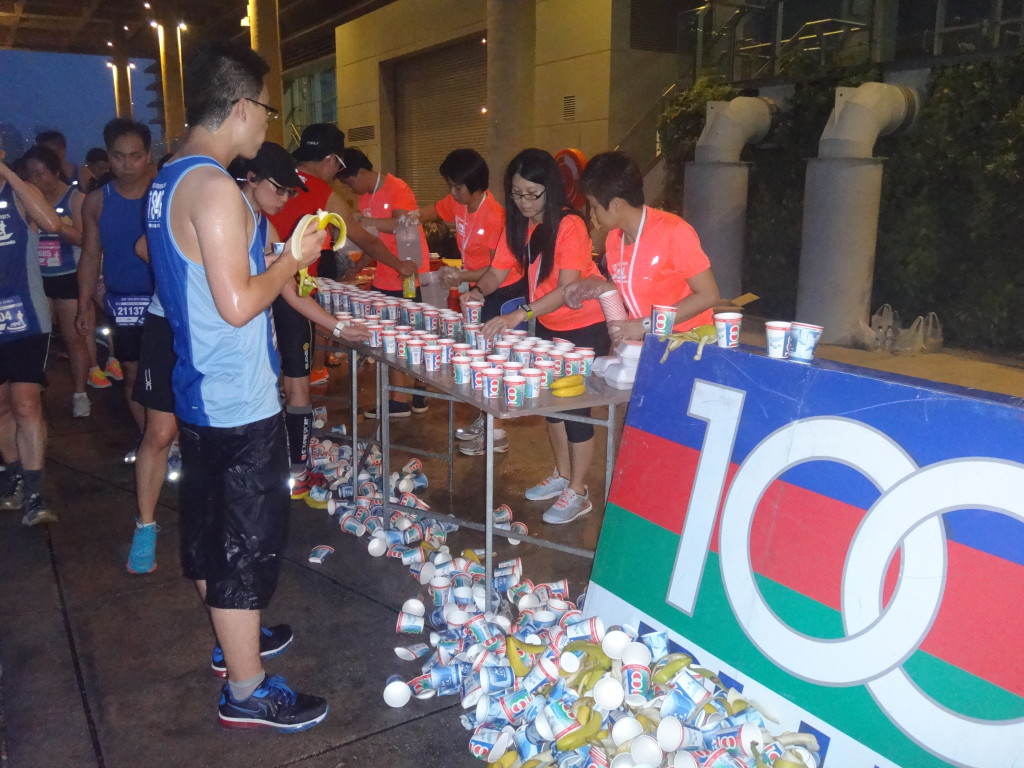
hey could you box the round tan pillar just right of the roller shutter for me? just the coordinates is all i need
[486,0,537,182]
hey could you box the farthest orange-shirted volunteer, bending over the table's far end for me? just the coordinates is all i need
[338,146,430,419]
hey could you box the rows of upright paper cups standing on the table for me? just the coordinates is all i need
[319,280,594,408]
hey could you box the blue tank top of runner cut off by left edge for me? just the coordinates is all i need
[0,182,50,344]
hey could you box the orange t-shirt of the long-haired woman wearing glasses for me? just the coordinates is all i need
[494,214,604,331]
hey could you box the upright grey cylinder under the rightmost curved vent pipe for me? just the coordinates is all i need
[797,158,883,345]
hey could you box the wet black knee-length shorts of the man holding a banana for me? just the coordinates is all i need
[178,414,290,610]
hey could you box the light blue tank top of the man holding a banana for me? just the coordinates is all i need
[145,156,281,427]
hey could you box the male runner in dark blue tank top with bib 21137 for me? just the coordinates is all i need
[75,118,153,432]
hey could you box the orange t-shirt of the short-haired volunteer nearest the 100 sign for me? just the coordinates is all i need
[604,206,713,331]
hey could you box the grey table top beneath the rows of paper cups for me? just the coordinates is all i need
[342,342,633,419]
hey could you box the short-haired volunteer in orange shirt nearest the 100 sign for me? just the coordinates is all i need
[566,152,720,343]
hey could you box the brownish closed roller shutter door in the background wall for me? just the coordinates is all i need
[394,35,485,205]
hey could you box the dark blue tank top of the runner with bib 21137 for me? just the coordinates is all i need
[99,181,154,296]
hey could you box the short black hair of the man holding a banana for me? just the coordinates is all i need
[184,41,270,131]
